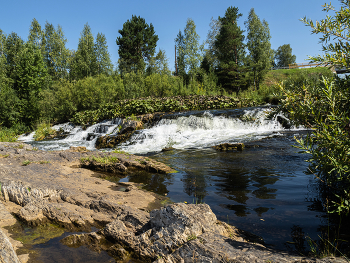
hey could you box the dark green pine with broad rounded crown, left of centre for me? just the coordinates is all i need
[116,15,159,73]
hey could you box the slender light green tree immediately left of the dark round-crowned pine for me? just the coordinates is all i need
[95,33,113,76]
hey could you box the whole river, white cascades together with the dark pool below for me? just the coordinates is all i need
[20,107,327,258]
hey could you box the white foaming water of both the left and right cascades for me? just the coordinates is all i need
[19,108,297,154]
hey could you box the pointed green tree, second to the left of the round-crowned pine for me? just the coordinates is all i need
[70,24,97,80]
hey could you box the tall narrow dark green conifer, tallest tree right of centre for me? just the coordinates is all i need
[215,6,245,91]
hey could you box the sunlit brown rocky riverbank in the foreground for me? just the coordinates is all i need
[0,143,346,263]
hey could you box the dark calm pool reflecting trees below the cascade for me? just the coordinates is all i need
[121,131,325,253]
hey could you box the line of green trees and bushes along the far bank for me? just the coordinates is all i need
[0,7,295,132]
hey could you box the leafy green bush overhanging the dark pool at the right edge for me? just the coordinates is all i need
[279,75,350,209]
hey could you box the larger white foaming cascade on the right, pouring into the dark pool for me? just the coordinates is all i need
[119,109,302,154]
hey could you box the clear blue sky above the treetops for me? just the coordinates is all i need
[0,0,340,70]
